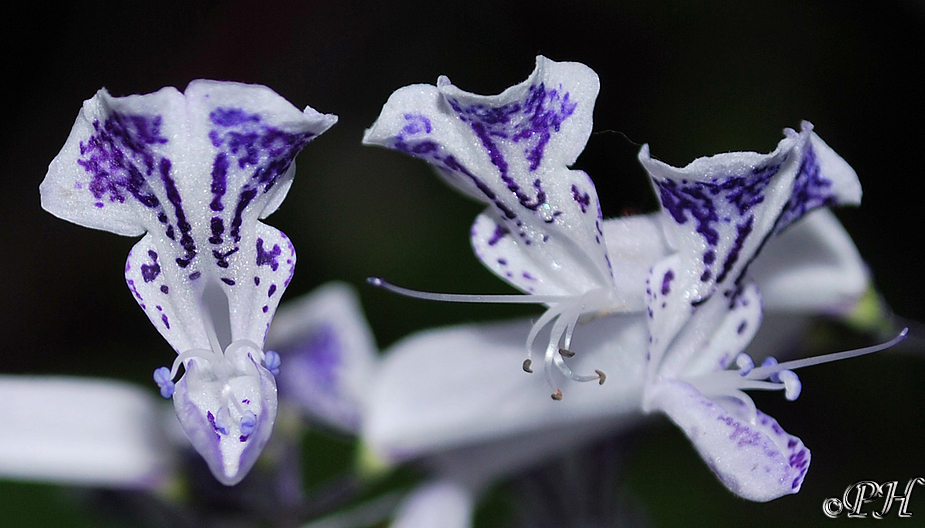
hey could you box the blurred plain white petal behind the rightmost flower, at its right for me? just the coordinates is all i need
[749,209,871,315]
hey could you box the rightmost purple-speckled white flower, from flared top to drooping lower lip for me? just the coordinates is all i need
[639,123,861,501]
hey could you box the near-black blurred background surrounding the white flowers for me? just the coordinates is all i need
[0,0,925,526]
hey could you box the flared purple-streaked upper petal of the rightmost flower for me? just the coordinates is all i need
[639,122,860,336]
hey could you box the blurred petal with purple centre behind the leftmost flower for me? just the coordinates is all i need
[267,283,379,433]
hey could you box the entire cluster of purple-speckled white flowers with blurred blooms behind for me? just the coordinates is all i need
[27,57,902,526]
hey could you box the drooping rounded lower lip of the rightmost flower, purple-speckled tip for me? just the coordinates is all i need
[652,381,810,502]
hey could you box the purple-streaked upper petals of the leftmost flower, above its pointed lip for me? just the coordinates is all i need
[41,81,336,352]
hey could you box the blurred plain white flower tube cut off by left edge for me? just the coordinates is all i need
[0,376,180,489]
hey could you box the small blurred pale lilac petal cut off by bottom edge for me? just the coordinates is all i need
[390,480,475,528]
